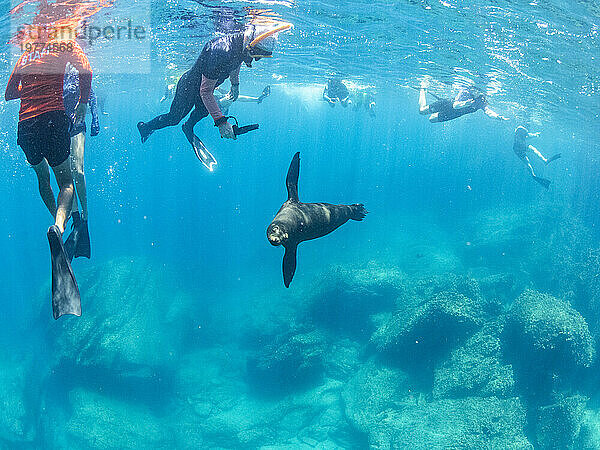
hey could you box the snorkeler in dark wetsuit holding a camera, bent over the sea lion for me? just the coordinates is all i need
[137,24,291,170]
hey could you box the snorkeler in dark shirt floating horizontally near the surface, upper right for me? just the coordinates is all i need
[419,81,508,123]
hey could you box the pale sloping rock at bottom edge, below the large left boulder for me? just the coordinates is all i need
[62,389,172,449]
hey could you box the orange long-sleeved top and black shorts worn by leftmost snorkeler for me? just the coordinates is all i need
[7,41,92,167]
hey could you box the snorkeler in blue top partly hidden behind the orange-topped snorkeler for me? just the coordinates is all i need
[63,61,100,260]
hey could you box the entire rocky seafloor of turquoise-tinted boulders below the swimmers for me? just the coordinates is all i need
[0,209,600,449]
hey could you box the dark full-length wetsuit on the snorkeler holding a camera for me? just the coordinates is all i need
[144,33,251,134]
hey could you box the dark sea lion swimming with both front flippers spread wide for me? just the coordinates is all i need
[267,152,367,287]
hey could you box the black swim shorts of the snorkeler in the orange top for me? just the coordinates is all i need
[17,111,71,167]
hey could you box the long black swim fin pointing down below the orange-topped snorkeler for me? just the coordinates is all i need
[47,225,81,320]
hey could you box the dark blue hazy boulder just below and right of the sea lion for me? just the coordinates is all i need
[309,261,403,338]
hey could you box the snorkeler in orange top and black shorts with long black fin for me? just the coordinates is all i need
[5,39,92,319]
